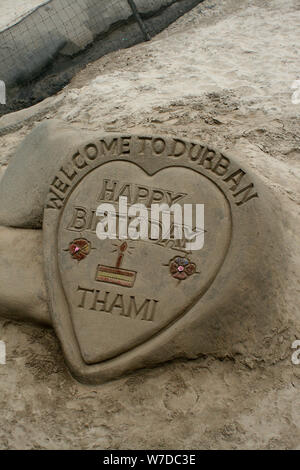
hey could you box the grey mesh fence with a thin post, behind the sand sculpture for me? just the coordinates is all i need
[0,0,203,87]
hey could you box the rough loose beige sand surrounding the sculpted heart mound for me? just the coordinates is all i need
[0,0,300,449]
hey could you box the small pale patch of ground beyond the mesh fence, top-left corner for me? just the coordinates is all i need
[0,0,48,31]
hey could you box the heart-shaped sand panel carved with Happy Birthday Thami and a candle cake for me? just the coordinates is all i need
[45,161,231,372]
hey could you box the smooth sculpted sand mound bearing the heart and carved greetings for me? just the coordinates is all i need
[0,121,283,383]
